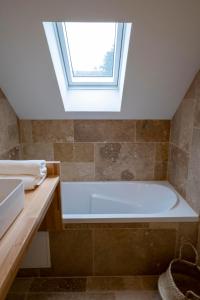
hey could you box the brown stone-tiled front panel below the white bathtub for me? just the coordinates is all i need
[17,223,198,277]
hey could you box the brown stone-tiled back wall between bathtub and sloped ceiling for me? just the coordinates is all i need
[20,120,170,181]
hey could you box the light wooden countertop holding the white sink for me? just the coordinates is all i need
[0,165,60,300]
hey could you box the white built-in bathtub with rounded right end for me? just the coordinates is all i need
[61,181,198,223]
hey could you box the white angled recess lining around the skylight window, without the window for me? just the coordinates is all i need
[43,21,133,113]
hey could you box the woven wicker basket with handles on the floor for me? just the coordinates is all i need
[158,243,200,300]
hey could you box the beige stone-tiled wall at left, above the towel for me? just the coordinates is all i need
[0,89,20,159]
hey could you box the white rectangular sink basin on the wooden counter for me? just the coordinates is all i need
[0,179,24,238]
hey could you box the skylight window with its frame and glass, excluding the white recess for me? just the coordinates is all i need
[55,22,125,88]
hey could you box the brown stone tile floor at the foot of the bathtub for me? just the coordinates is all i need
[6,276,161,300]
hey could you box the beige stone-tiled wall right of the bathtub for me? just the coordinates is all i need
[169,72,200,213]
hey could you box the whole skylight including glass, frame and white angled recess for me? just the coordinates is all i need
[43,22,132,112]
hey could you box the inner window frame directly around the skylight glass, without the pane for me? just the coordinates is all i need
[53,22,126,89]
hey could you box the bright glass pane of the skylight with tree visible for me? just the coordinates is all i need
[65,22,116,78]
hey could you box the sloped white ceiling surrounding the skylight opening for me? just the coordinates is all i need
[0,0,200,119]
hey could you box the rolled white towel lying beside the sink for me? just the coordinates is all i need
[0,160,47,177]
